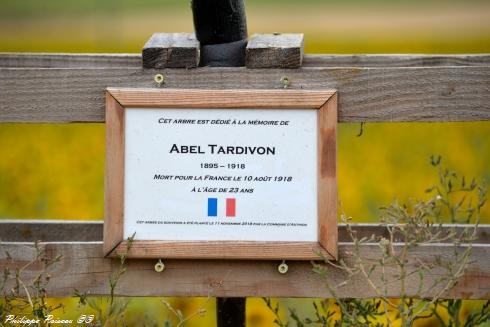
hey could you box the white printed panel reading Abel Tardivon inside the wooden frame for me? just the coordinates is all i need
[124,108,318,242]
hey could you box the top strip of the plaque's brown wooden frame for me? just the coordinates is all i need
[107,88,335,109]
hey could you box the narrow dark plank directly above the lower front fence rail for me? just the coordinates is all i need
[0,219,490,244]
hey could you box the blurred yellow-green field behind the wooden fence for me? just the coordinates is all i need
[0,0,490,326]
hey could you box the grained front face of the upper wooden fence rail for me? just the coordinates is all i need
[0,66,490,122]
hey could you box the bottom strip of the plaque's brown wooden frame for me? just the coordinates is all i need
[111,240,332,260]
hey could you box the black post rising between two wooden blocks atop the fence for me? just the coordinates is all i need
[192,0,247,67]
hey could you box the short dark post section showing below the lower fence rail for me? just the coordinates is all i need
[216,297,246,327]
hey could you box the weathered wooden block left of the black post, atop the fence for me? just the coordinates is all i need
[142,33,200,68]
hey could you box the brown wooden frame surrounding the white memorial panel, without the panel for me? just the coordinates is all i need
[103,88,337,260]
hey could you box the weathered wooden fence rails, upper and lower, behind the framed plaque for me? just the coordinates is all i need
[0,54,490,299]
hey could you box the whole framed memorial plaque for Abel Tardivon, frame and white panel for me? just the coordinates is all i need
[104,89,337,260]
